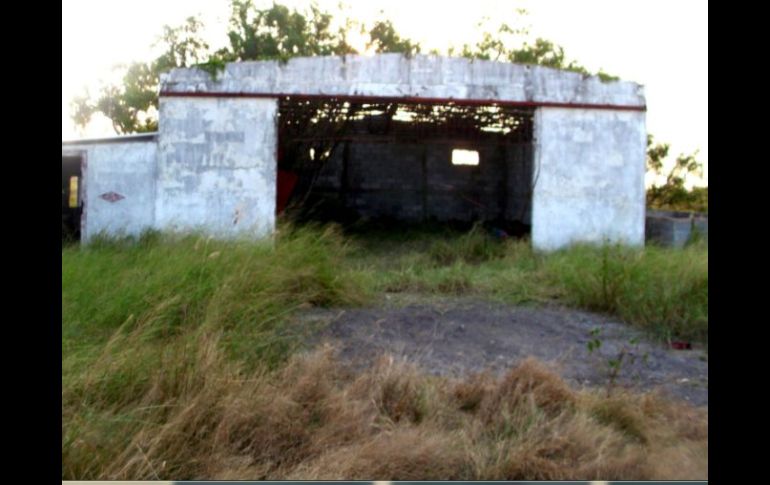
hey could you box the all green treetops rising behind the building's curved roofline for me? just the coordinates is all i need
[72,0,617,134]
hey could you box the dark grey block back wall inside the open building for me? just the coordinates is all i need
[314,142,531,224]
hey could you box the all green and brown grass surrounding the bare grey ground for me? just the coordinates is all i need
[62,226,708,480]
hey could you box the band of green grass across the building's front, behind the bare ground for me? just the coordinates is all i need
[62,226,708,360]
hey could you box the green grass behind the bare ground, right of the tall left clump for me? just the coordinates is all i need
[344,226,708,345]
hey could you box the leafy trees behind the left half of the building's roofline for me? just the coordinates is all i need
[72,0,404,134]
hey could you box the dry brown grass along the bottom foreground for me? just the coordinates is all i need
[62,333,708,480]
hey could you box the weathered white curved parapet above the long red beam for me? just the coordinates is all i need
[161,54,645,106]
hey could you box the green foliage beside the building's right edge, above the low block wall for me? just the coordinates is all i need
[647,135,708,213]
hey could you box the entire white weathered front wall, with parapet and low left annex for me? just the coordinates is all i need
[63,54,646,246]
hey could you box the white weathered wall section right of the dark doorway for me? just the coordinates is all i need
[532,108,646,250]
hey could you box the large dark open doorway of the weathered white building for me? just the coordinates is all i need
[276,96,534,235]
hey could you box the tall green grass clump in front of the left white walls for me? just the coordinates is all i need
[62,226,370,402]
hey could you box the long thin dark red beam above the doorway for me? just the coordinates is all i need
[160,91,647,111]
